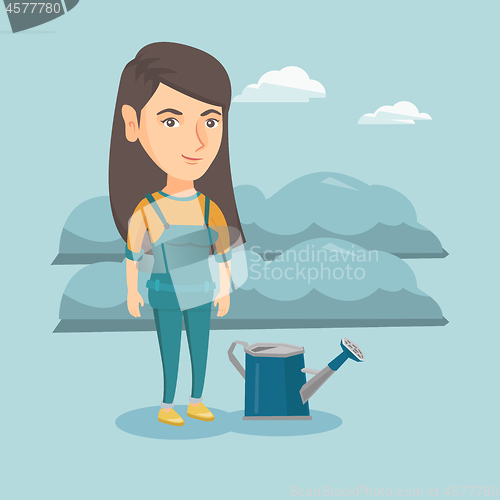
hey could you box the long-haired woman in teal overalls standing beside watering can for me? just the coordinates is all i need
[109,42,244,425]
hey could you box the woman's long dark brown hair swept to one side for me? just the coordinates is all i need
[109,42,245,244]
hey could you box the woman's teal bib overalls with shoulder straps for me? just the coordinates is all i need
[142,191,218,408]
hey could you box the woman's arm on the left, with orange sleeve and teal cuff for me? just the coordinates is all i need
[125,210,146,318]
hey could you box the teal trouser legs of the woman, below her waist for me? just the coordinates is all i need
[153,303,211,404]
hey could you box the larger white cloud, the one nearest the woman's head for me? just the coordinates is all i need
[233,66,326,102]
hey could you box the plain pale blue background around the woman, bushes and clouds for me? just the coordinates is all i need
[0,0,500,499]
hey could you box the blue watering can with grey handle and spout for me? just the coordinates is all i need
[227,338,364,420]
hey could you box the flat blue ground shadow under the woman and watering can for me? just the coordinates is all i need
[115,406,342,440]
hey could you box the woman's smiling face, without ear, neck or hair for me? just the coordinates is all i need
[130,83,224,181]
